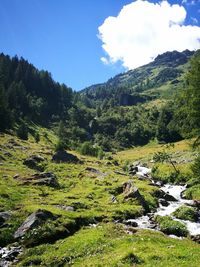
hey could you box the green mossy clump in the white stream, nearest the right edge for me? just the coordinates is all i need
[173,205,198,222]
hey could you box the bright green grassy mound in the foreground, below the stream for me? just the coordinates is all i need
[17,224,199,267]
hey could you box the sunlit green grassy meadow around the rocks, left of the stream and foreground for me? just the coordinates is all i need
[0,128,200,267]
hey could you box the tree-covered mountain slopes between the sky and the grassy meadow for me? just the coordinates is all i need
[0,50,199,154]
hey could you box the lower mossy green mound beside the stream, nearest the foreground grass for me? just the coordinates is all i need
[155,216,189,236]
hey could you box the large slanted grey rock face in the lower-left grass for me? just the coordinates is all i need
[14,209,56,239]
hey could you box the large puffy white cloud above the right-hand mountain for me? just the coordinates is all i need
[99,0,200,69]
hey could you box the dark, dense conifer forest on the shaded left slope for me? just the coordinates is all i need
[0,54,73,129]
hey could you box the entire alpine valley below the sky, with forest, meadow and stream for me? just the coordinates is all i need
[0,50,200,267]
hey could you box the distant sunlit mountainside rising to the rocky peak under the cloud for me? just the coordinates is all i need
[81,50,194,106]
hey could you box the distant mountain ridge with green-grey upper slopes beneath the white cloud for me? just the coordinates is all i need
[80,50,195,104]
